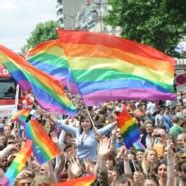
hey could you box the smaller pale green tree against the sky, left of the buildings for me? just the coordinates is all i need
[22,21,59,51]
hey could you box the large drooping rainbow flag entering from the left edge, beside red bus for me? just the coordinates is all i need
[0,45,77,116]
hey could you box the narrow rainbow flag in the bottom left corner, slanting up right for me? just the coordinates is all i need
[5,140,32,186]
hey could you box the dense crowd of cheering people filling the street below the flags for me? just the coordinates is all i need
[0,90,186,186]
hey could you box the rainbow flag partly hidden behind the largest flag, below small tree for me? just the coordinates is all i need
[27,39,78,93]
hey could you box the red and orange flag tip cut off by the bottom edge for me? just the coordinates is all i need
[51,176,96,186]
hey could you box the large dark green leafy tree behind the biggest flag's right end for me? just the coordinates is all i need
[105,0,186,56]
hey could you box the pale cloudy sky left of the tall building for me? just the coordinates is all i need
[0,0,57,52]
